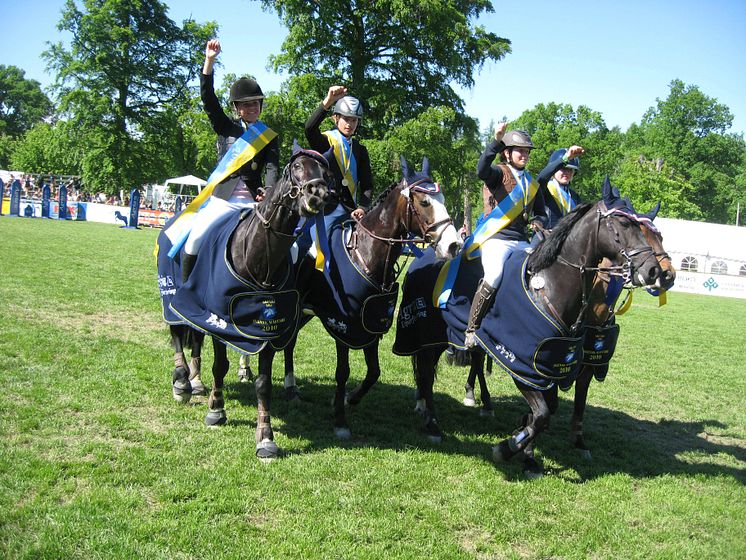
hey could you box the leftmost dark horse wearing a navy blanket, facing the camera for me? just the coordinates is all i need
[158,146,333,460]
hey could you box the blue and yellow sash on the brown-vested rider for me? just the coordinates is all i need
[433,166,539,309]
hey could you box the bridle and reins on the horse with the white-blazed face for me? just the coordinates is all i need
[347,177,453,289]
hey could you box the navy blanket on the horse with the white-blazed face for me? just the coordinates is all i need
[303,222,399,349]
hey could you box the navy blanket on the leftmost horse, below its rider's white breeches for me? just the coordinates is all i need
[158,212,300,354]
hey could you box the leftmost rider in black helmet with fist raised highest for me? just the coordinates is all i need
[181,39,280,280]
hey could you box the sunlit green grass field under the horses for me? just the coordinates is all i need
[0,217,746,559]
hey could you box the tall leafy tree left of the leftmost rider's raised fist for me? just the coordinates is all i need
[43,0,216,192]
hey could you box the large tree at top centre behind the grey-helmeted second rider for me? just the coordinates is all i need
[253,0,510,138]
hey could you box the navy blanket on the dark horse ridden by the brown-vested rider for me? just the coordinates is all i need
[394,247,583,390]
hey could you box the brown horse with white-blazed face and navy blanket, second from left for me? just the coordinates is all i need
[285,156,462,439]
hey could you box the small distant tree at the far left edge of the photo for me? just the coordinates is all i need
[0,64,53,138]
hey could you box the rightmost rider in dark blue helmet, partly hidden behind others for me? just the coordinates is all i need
[534,146,585,232]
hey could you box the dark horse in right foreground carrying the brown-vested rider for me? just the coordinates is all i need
[393,181,661,476]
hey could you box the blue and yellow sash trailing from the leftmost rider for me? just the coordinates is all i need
[167,121,277,258]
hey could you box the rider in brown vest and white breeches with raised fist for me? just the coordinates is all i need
[465,122,542,348]
